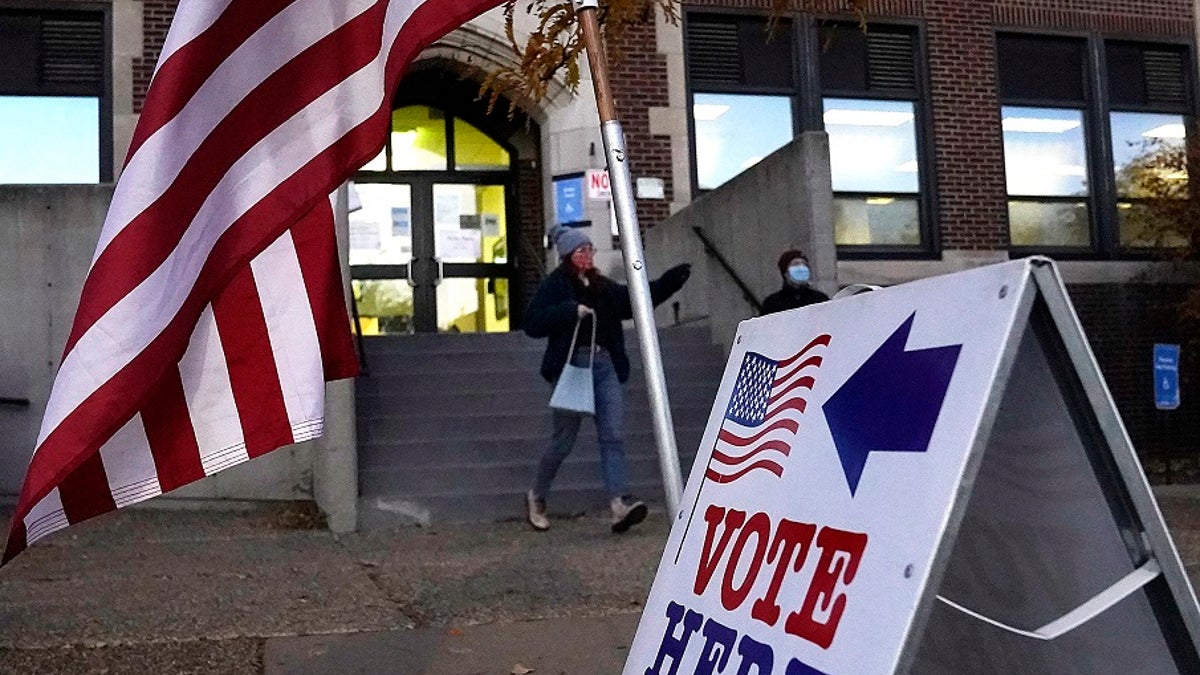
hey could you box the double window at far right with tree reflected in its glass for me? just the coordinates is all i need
[997,35,1190,257]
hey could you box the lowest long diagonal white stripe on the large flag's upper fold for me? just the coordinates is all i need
[37,40,405,444]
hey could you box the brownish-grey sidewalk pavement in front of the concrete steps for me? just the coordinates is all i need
[0,491,1200,675]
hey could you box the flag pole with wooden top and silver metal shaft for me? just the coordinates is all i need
[576,0,683,514]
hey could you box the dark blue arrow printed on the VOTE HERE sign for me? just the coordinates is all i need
[821,312,962,495]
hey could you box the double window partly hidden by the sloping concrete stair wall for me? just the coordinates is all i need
[686,13,932,253]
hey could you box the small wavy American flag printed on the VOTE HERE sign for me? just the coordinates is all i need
[704,335,830,483]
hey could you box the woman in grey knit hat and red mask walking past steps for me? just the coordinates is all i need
[524,226,691,532]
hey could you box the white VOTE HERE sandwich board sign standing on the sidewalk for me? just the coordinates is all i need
[625,258,1200,675]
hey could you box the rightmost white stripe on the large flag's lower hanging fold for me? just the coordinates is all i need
[250,232,325,425]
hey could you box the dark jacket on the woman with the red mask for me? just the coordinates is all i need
[524,264,690,382]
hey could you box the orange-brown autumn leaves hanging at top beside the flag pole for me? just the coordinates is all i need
[481,0,869,112]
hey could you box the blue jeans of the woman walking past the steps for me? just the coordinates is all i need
[533,347,629,498]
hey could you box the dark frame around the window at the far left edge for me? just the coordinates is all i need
[0,0,115,184]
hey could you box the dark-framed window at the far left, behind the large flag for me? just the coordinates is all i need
[0,10,113,184]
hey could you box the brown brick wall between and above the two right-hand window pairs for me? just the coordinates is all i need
[667,0,1194,250]
